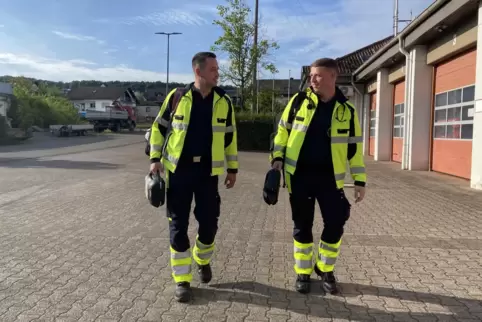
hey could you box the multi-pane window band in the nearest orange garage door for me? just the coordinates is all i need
[433,85,475,140]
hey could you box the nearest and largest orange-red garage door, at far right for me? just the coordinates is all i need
[432,49,476,179]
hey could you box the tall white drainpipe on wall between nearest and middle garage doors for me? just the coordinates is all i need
[398,35,412,170]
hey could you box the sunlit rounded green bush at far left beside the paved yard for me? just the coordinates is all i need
[7,77,80,129]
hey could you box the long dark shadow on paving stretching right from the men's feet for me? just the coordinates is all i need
[193,281,482,321]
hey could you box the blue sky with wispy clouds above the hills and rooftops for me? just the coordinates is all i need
[0,0,433,82]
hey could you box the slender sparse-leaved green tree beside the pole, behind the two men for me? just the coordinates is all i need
[211,0,279,108]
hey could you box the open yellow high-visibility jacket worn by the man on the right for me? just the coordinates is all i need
[270,88,366,189]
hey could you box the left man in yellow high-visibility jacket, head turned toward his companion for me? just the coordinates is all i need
[150,52,238,302]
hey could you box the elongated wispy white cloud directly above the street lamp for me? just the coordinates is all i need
[95,9,211,26]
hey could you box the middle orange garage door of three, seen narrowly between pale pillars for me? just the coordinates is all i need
[392,81,405,162]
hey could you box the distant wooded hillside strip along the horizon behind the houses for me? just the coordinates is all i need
[0,76,234,93]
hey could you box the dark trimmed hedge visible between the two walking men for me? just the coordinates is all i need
[236,113,276,152]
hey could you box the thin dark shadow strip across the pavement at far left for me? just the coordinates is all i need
[0,158,122,170]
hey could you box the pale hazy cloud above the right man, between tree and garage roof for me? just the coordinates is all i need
[260,0,433,57]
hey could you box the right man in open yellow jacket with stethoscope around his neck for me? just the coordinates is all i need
[270,58,366,294]
